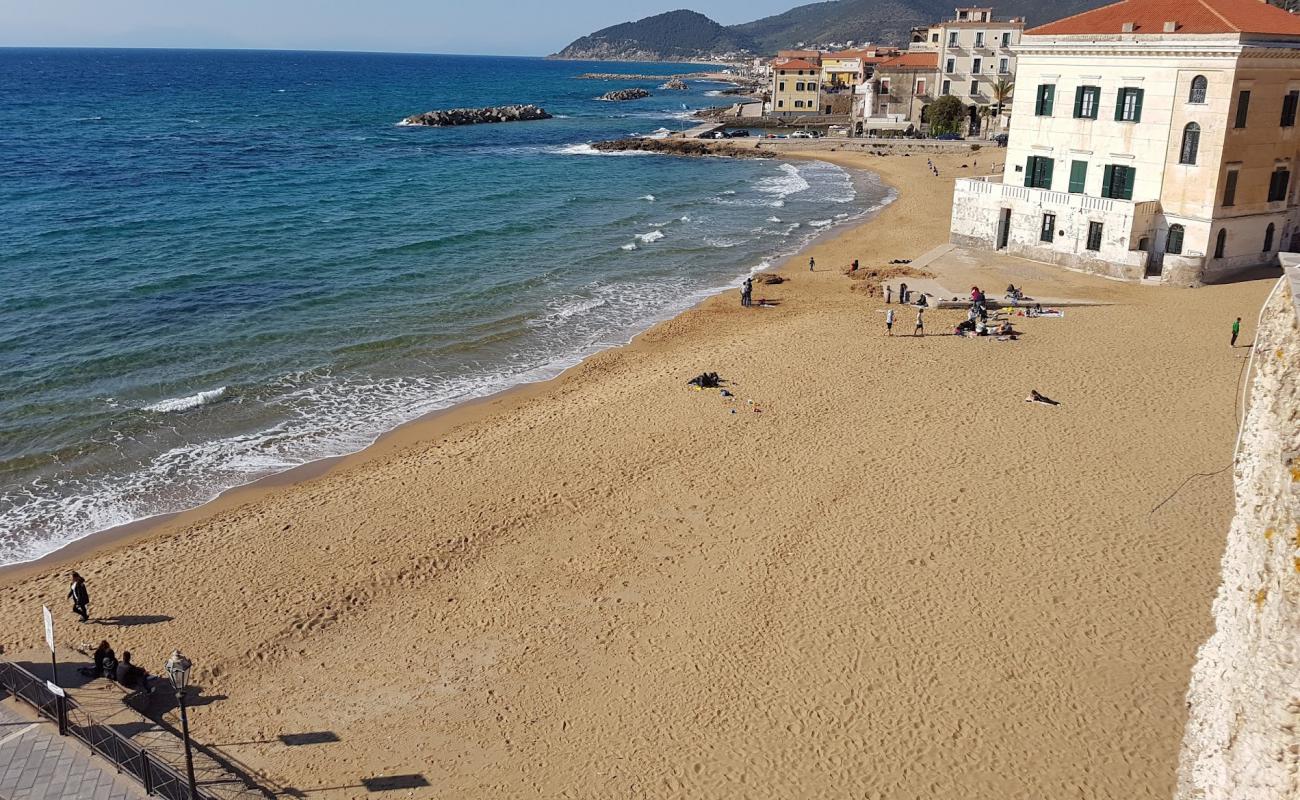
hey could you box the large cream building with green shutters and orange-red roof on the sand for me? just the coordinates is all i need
[952,0,1300,282]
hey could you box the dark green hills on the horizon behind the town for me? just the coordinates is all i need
[553,0,1109,61]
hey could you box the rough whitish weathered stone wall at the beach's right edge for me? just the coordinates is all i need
[1175,278,1300,800]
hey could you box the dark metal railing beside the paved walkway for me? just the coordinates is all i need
[0,661,265,800]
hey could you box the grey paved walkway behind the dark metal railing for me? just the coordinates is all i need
[0,695,146,800]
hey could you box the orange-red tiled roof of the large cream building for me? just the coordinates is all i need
[1024,0,1300,36]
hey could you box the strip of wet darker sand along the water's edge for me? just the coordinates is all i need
[0,148,901,588]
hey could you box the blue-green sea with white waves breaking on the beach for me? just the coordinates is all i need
[0,49,892,565]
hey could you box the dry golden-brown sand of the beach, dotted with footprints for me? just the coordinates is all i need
[0,151,1270,800]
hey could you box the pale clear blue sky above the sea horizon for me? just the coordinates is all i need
[0,0,807,56]
